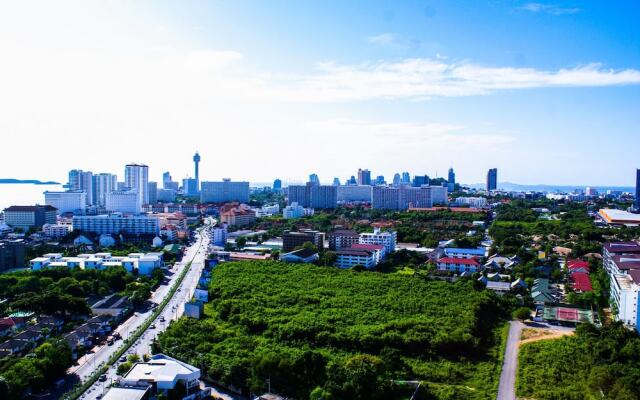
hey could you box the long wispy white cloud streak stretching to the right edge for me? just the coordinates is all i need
[268,58,640,102]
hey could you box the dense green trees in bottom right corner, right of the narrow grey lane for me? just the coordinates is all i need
[517,324,640,400]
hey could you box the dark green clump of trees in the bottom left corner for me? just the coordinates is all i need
[0,339,72,400]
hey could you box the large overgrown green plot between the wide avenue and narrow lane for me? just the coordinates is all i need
[155,261,511,399]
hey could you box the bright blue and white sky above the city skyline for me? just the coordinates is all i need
[0,0,640,186]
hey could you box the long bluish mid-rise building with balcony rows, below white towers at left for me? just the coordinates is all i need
[73,213,160,235]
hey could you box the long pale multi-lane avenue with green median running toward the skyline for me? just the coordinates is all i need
[72,230,209,400]
